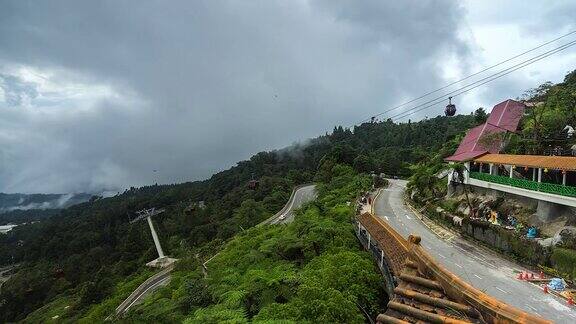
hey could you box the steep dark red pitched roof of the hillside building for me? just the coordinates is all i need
[445,99,525,162]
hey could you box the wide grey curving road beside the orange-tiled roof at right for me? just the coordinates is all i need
[374,180,576,323]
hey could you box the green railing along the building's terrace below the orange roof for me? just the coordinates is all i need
[470,172,576,197]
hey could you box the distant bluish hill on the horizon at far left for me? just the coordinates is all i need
[0,193,92,213]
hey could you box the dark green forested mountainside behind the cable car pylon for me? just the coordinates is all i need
[0,105,475,322]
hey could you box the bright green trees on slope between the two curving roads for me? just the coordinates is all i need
[126,165,384,323]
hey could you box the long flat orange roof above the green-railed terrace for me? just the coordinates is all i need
[474,154,576,171]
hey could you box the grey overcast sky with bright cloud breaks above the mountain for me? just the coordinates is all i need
[0,0,576,193]
